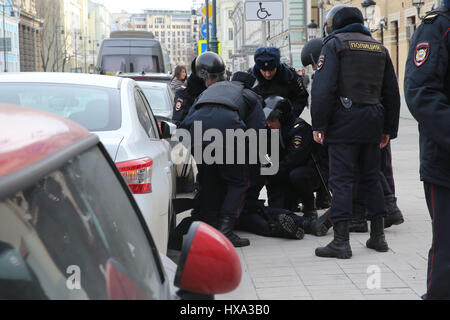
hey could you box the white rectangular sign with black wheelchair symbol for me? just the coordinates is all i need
[245,1,283,21]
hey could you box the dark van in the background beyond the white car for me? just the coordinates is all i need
[97,31,170,75]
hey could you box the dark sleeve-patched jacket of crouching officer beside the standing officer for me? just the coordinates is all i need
[275,118,315,179]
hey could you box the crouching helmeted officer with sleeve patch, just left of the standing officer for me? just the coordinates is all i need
[264,97,320,218]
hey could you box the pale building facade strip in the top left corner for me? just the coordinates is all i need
[0,0,20,72]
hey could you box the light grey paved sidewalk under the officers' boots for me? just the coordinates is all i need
[216,118,432,300]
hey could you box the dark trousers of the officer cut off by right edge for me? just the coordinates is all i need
[424,182,450,300]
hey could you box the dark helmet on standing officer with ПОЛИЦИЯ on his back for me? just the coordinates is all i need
[324,4,364,36]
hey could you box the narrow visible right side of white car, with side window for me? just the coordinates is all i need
[134,86,173,238]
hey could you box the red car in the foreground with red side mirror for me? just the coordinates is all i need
[0,101,242,300]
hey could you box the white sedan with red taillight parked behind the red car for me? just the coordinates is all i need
[0,73,176,253]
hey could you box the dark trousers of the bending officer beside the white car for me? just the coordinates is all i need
[197,164,249,226]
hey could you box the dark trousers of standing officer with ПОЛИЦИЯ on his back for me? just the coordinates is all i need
[328,144,386,224]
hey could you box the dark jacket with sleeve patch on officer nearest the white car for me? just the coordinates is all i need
[172,74,206,126]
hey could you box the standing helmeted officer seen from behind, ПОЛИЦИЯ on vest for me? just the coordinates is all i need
[311,5,400,259]
